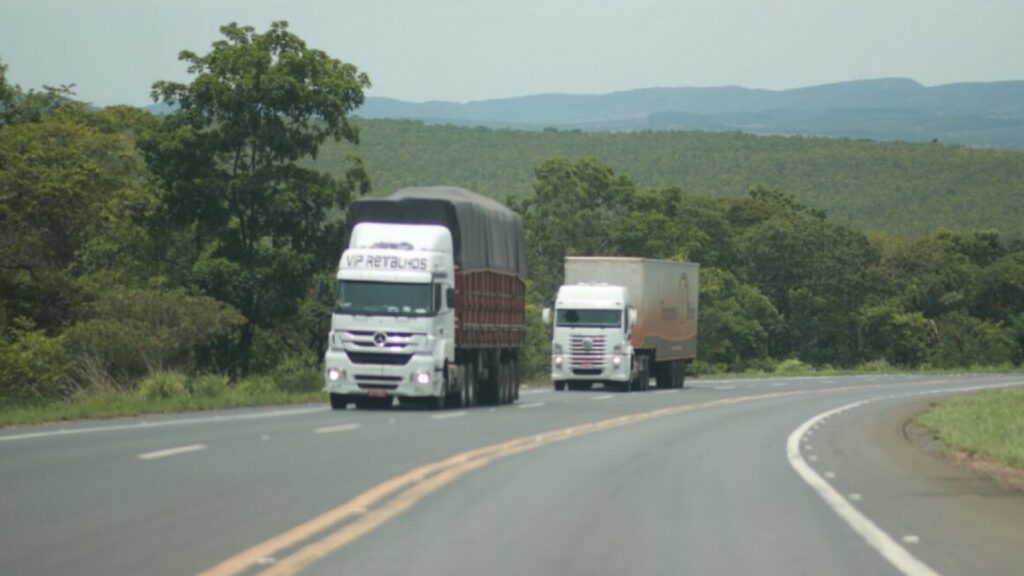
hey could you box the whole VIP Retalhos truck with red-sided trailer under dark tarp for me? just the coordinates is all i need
[324,187,526,410]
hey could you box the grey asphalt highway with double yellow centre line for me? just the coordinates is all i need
[0,375,1024,575]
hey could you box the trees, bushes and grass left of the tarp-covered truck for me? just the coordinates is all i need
[0,23,360,416]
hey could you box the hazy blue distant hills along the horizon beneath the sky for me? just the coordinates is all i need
[356,78,1024,150]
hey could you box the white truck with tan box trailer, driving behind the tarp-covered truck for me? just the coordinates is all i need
[544,257,700,390]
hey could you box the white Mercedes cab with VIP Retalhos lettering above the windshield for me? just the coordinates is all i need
[324,222,456,408]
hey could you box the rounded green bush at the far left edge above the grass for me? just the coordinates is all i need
[0,321,75,403]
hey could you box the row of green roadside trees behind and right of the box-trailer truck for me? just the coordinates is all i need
[512,159,1024,375]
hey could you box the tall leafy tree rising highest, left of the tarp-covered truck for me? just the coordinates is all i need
[142,22,370,371]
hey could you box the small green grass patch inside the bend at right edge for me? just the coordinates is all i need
[914,389,1024,469]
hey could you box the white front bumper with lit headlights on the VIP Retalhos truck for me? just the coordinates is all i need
[324,349,444,398]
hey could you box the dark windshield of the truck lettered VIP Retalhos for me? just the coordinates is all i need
[334,280,436,316]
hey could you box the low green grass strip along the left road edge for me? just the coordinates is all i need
[0,390,327,426]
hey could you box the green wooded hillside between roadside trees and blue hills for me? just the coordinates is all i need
[315,118,1024,237]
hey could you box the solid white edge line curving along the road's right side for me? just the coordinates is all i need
[785,382,1020,576]
